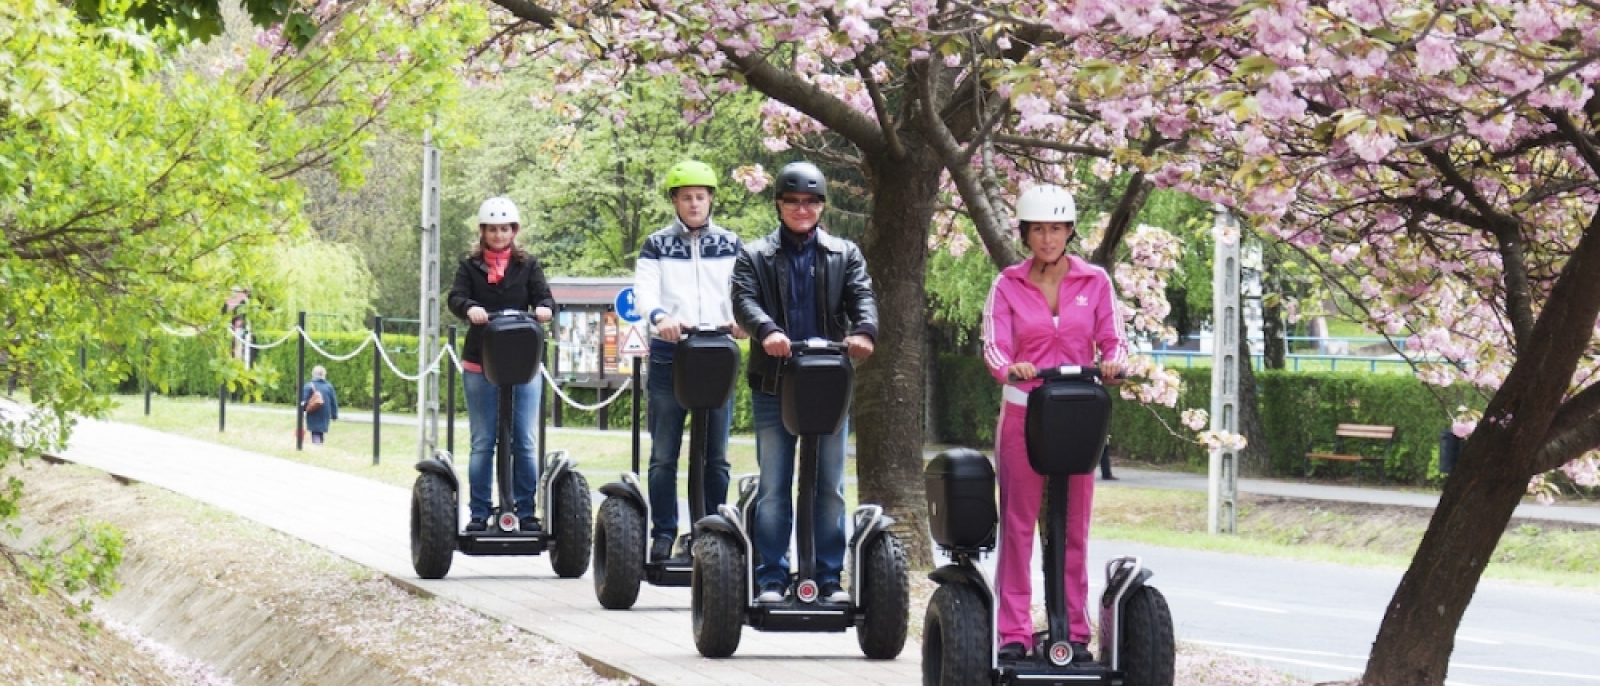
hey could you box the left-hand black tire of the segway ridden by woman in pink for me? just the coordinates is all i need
[922,584,994,686]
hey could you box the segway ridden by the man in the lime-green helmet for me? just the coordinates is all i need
[594,326,739,609]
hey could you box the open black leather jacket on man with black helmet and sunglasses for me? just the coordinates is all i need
[733,227,878,393]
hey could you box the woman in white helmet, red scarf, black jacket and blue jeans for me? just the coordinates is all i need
[450,197,555,531]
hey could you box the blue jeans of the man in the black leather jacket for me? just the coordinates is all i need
[750,390,850,587]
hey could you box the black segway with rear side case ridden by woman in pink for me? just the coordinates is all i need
[922,366,1176,686]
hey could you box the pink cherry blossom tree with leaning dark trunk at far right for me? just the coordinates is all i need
[1010,0,1600,686]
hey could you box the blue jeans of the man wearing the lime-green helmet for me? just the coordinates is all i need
[648,355,733,537]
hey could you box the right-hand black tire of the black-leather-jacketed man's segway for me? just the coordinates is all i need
[851,531,910,660]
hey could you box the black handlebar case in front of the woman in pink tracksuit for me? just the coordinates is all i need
[1026,379,1110,477]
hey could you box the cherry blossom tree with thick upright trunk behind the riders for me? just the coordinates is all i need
[491,0,1203,563]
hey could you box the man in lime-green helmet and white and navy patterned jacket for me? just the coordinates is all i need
[634,160,744,560]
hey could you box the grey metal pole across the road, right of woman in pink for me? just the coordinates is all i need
[1206,205,1242,534]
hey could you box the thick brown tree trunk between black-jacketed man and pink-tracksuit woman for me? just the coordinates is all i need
[851,146,941,568]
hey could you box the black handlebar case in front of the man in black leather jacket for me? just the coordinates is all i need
[778,345,856,437]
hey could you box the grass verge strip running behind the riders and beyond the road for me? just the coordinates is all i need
[110,397,1600,590]
